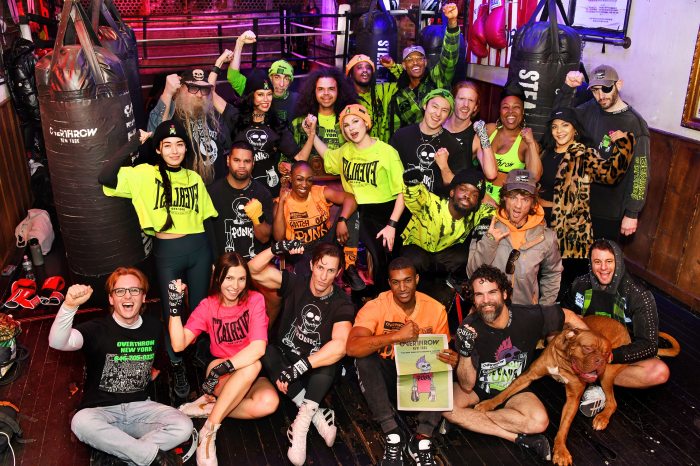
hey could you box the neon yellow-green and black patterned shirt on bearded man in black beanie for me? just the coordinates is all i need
[401,183,495,254]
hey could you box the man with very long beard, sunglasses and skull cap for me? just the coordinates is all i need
[148,56,238,184]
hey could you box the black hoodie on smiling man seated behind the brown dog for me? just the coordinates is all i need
[561,241,659,364]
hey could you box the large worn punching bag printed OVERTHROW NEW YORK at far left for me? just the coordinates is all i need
[36,0,150,277]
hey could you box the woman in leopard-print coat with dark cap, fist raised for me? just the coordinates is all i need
[540,108,634,296]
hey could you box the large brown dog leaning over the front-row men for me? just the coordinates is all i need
[474,316,630,465]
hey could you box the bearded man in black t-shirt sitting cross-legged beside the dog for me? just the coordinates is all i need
[443,265,586,460]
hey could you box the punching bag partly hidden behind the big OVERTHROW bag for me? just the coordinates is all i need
[90,0,146,129]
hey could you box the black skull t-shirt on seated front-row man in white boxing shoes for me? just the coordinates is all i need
[277,270,355,360]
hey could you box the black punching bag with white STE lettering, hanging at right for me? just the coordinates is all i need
[508,0,581,139]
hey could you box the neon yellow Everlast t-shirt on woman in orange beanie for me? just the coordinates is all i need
[323,140,403,205]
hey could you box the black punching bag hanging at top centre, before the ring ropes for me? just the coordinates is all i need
[353,0,398,81]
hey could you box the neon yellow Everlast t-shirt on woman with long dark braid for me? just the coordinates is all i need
[102,164,218,236]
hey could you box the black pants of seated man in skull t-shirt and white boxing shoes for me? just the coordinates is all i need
[261,344,338,404]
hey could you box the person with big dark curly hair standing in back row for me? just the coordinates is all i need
[292,68,357,175]
